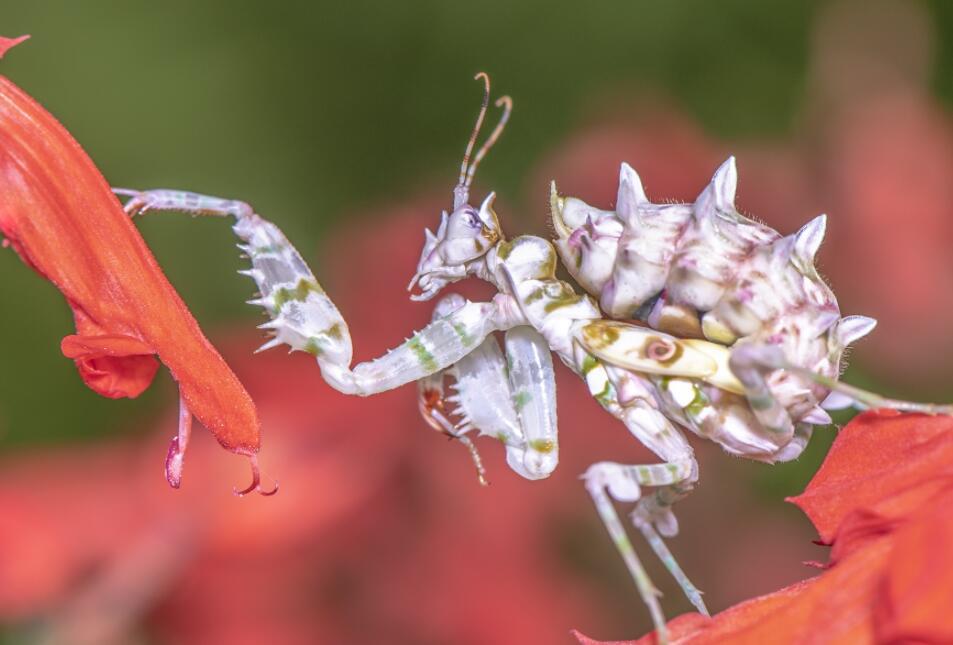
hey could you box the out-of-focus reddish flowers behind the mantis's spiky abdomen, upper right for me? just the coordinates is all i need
[531,0,953,388]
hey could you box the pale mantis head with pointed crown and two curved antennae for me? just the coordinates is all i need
[407,72,513,300]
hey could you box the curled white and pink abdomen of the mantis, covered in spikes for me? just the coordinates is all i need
[551,159,875,462]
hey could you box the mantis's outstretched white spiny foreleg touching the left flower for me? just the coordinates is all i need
[117,189,521,396]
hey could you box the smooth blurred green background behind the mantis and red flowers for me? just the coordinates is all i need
[0,0,953,640]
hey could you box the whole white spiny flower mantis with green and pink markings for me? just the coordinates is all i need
[116,74,947,640]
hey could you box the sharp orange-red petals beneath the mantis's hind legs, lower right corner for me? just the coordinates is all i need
[579,410,953,645]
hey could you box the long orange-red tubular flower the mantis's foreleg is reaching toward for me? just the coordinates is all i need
[0,38,259,487]
